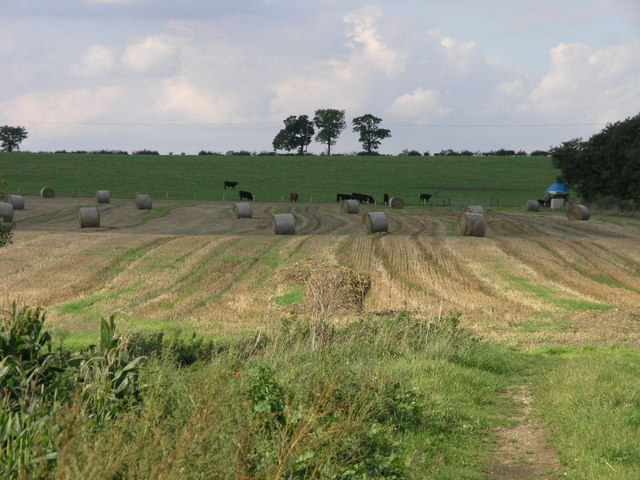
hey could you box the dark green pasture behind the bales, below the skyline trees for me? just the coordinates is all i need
[0,153,559,206]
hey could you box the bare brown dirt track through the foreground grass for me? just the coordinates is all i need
[484,385,562,480]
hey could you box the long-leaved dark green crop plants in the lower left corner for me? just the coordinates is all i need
[0,303,144,478]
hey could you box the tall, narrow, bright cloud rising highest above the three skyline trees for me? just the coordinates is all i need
[344,7,406,77]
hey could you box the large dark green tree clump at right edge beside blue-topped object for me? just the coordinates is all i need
[551,114,640,207]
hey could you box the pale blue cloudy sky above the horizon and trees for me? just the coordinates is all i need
[0,0,640,154]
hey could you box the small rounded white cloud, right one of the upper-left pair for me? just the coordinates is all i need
[122,35,178,74]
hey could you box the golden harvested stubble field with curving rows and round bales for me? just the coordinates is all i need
[0,196,640,350]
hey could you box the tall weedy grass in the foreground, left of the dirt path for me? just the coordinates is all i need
[51,314,521,479]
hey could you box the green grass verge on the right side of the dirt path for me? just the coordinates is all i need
[537,350,640,480]
